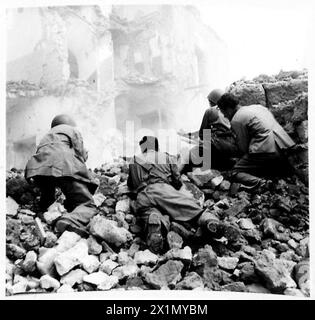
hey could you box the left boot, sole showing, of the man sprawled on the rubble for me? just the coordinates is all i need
[146,211,164,253]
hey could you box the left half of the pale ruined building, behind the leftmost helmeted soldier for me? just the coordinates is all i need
[6,7,116,168]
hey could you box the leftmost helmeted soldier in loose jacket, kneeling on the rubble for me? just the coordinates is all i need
[25,114,98,236]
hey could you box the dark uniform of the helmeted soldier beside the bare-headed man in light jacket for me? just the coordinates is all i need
[190,107,238,169]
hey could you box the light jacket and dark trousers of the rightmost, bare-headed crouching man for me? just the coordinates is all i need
[231,105,295,186]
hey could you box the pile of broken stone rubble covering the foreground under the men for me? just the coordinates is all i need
[6,159,309,296]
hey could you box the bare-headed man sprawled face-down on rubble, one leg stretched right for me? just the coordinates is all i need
[127,136,241,253]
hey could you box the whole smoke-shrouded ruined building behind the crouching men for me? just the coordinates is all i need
[6,5,227,168]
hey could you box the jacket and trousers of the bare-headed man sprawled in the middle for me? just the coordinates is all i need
[128,151,202,225]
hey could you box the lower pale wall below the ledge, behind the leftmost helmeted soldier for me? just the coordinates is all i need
[7,86,115,167]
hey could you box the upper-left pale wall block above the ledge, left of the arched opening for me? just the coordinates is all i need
[7,8,69,86]
